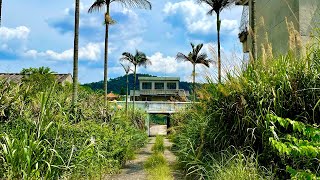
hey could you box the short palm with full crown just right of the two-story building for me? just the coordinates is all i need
[176,43,213,102]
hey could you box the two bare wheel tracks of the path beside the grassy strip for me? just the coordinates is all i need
[104,137,183,180]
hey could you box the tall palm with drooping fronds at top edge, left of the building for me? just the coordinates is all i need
[88,0,151,111]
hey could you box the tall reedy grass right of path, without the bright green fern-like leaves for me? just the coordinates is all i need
[173,33,320,179]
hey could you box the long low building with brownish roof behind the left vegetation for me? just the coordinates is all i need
[0,73,73,85]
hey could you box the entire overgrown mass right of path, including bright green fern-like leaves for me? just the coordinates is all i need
[172,35,320,179]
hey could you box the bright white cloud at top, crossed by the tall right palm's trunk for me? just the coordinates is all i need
[163,0,239,34]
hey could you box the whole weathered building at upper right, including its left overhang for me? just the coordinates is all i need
[236,0,320,57]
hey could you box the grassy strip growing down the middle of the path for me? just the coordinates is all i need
[144,136,173,180]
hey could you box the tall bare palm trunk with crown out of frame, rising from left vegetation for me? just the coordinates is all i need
[72,0,80,117]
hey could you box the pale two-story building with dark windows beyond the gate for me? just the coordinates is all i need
[130,77,189,101]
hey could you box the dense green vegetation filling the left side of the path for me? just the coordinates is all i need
[0,70,147,179]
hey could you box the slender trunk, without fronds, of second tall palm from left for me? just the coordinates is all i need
[103,4,110,115]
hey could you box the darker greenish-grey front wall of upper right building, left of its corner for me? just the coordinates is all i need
[252,0,300,56]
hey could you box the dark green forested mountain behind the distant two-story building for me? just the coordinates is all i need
[83,74,192,95]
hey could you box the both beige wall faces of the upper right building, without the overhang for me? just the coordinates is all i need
[248,0,320,56]
